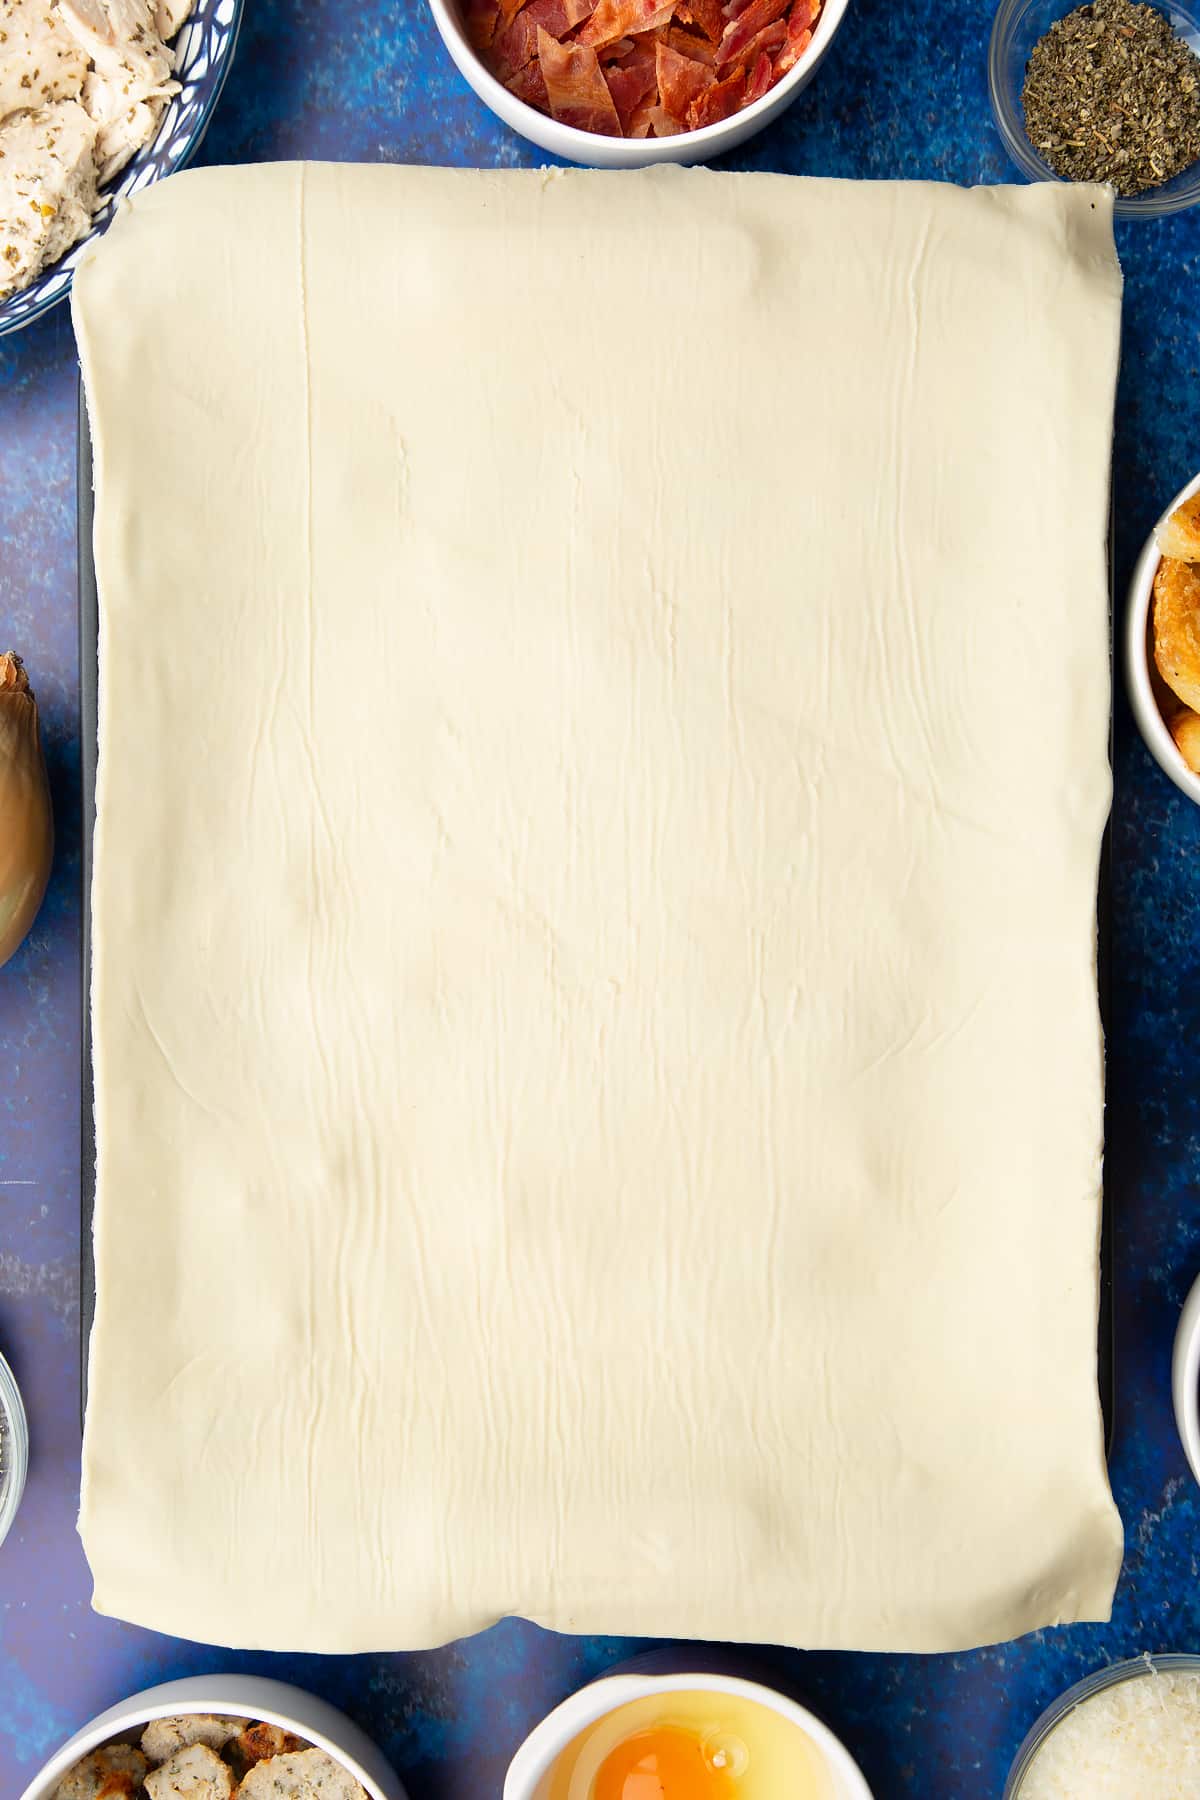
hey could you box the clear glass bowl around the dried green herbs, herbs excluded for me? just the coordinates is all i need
[988,0,1200,220]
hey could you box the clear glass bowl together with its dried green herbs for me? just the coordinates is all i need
[988,0,1200,218]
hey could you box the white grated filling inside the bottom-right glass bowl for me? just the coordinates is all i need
[1018,1660,1200,1800]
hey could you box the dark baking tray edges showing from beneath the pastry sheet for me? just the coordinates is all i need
[76,382,1115,1449]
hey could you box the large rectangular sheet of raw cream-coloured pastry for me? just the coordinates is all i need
[74,166,1121,1651]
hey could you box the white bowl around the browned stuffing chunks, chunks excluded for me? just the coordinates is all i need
[22,1676,405,1800]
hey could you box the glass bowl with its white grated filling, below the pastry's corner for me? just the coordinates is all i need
[1004,1656,1200,1800]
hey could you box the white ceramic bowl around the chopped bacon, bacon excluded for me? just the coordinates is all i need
[430,0,849,169]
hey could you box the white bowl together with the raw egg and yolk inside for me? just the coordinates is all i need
[504,1665,871,1800]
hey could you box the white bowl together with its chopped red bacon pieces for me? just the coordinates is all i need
[430,0,849,169]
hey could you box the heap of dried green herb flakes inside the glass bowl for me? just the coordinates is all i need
[1022,0,1200,196]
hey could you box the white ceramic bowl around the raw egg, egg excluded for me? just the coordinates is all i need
[504,1669,871,1800]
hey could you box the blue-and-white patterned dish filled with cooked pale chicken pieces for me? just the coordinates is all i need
[0,0,243,335]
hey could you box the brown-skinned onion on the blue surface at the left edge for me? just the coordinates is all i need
[0,650,54,968]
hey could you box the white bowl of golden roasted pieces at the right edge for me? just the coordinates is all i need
[1124,475,1200,805]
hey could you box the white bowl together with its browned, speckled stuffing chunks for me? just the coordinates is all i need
[22,1676,405,1800]
